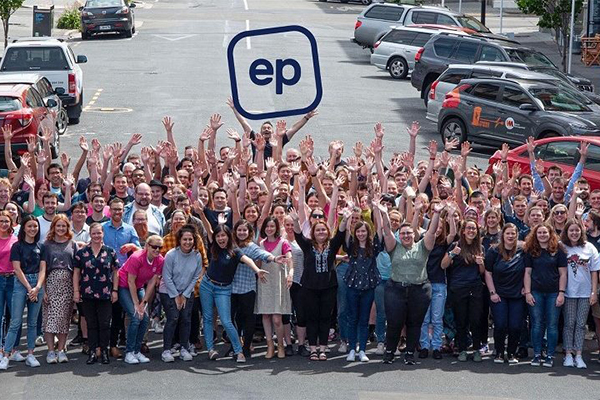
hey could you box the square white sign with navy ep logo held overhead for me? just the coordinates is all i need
[227,25,323,120]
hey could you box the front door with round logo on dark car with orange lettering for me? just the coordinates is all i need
[496,83,536,145]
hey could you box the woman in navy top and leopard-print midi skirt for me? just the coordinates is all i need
[40,214,77,364]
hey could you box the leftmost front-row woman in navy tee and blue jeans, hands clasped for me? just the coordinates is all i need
[0,216,46,369]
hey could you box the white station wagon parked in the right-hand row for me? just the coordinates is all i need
[371,25,462,79]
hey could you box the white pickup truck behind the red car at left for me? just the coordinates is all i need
[0,37,87,124]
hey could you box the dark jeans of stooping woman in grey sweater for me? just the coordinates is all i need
[159,293,194,351]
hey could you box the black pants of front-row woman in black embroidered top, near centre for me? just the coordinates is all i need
[302,287,337,346]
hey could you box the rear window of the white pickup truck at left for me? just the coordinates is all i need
[2,47,69,71]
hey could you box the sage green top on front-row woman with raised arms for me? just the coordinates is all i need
[389,240,429,285]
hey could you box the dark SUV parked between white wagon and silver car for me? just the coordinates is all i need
[411,33,592,104]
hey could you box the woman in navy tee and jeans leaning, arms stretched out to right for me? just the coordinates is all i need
[200,224,268,363]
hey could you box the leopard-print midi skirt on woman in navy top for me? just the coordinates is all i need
[42,269,73,334]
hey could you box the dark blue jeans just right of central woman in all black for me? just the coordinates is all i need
[346,287,375,351]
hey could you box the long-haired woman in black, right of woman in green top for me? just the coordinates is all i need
[441,219,485,362]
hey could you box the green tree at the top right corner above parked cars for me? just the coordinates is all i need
[516,0,583,71]
